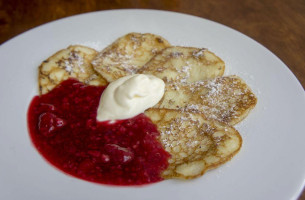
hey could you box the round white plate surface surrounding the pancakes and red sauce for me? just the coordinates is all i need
[0,10,305,200]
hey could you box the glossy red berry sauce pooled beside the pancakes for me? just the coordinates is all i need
[28,79,169,185]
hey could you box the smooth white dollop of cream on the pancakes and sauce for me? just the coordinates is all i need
[96,74,165,122]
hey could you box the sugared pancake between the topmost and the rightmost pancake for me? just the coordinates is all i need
[138,46,225,83]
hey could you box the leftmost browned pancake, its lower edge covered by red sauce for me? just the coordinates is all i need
[38,45,107,94]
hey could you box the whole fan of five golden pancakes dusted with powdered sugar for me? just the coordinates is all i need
[39,33,257,179]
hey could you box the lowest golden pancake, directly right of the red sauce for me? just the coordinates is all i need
[145,108,242,179]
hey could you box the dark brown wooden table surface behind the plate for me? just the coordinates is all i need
[0,0,305,200]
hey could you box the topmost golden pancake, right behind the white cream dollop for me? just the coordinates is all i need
[92,33,170,82]
